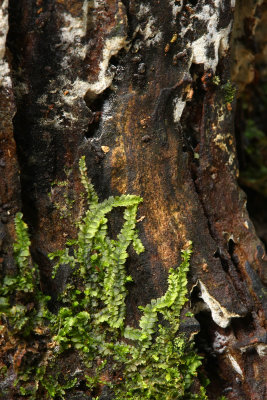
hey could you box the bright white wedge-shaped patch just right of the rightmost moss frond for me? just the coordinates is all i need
[198,280,241,328]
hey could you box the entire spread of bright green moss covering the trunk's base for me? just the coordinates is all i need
[1,158,207,400]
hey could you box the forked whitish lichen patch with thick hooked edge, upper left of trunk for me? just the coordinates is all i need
[37,0,127,124]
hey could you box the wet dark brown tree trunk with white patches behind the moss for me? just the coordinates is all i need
[0,0,267,400]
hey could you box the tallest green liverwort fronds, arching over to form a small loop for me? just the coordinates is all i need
[49,157,147,348]
